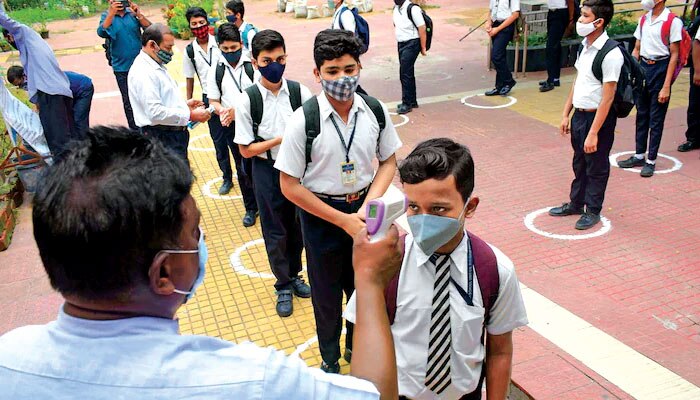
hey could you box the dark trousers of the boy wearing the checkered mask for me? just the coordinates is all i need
[299,195,366,365]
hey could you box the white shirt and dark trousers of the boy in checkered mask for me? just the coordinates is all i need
[275,93,402,365]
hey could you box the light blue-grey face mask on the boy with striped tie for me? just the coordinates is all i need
[408,201,469,255]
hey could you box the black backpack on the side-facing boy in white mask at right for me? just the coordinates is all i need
[578,39,644,118]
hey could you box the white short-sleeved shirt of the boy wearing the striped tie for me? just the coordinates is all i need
[343,234,528,400]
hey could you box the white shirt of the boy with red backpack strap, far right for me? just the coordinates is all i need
[634,8,683,60]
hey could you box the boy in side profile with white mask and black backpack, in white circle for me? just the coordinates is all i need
[549,0,624,230]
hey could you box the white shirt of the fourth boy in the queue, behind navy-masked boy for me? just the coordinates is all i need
[207,54,260,108]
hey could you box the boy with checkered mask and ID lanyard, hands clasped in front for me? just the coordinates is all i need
[275,29,401,372]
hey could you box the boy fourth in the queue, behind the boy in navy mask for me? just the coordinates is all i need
[207,23,258,227]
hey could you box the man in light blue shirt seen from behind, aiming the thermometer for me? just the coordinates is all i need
[0,127,401,400]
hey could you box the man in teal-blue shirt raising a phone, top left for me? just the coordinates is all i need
[97,0,151,131]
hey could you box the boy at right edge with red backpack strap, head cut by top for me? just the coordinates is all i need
[617,0,683,178]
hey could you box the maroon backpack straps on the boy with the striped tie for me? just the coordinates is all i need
[384,233,500,326]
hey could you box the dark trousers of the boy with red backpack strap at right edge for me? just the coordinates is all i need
[635,59,669,161]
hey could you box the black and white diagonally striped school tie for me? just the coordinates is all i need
[425,254,452,394]
